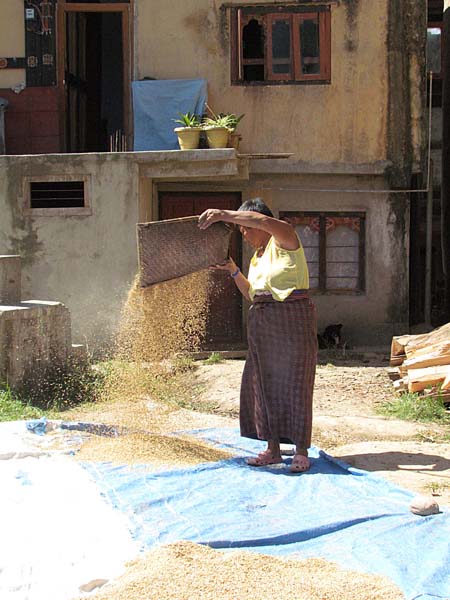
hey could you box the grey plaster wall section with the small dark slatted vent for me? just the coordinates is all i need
[0,154,139,350]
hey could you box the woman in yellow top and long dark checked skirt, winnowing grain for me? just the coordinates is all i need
[199,198,317,473]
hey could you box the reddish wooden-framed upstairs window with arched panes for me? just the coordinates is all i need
[231,5,331,85]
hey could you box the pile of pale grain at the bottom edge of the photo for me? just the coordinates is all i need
[75,542,404,600]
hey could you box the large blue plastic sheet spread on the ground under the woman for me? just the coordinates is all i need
[86,429,450,600]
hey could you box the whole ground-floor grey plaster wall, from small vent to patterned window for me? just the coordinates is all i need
[0,150,409,351]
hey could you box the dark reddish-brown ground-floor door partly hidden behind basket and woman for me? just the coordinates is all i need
[159,192,243,350]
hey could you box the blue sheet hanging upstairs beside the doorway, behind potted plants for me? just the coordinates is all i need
[132,79,207,151]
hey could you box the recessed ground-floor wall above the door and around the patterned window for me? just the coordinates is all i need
[154,173,409,346]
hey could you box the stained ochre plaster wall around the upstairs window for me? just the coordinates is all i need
[135,0,388,163]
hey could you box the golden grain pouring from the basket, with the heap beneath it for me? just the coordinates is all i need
[67,271,225,467]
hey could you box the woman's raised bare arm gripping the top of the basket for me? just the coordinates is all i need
[198,208,299,250]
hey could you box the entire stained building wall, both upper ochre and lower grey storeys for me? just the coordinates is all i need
[0,0,426,348]
